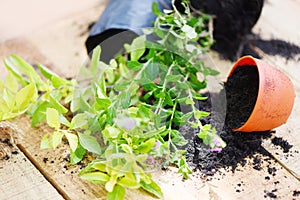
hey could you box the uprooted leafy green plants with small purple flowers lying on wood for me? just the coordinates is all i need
[0,2,225,199]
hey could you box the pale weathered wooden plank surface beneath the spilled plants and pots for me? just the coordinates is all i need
[0,0,300,200]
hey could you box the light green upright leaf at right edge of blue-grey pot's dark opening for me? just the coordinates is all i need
[130,35,146,61]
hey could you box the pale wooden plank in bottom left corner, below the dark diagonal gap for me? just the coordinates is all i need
[0,122,63,200]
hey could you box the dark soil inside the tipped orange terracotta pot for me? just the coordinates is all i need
[224,65,259,128]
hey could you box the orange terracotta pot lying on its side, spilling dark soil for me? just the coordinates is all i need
[228,56,295,132]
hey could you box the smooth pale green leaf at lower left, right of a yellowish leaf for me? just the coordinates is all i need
[78,133,102,155]
